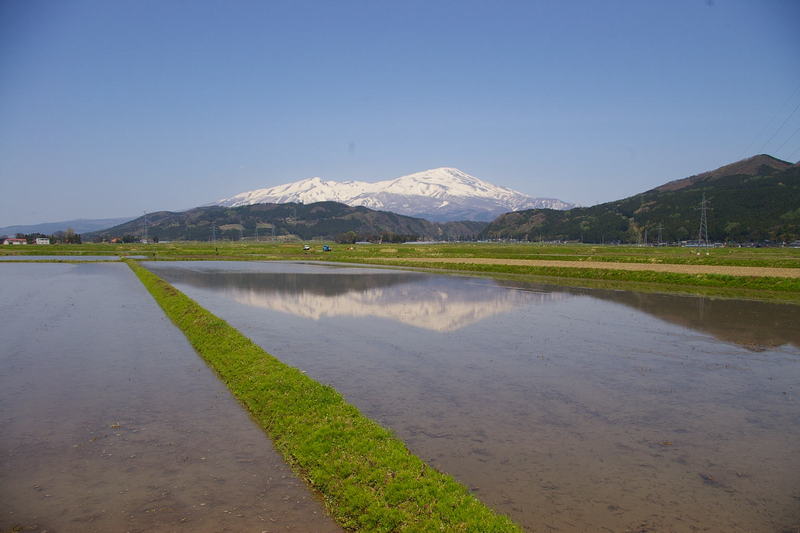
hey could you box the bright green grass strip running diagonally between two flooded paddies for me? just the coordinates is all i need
[127,261,521,533]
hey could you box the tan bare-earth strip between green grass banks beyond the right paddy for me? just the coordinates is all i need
[381,257,800,278]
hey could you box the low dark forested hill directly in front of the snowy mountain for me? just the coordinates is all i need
[84,202,486,242]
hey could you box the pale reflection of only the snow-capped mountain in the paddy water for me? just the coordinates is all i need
[225,283,568,331]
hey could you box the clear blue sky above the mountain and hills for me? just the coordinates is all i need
[0,0,800,226]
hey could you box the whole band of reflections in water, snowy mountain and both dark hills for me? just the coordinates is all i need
[155,263,800,351]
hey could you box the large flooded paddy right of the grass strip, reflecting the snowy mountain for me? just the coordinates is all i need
[147,262,800,532]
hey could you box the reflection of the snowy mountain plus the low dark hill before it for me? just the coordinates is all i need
[162,270,569,332]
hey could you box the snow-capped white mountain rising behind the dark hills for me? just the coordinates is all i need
[213,167,573,221]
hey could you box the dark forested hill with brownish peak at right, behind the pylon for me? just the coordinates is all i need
[482,154,800,243]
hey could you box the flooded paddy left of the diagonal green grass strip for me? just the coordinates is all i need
[0,263,340,533]
